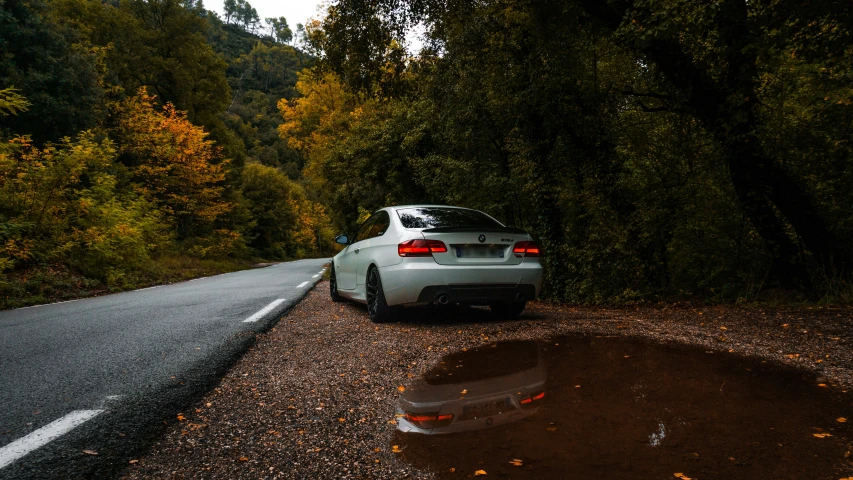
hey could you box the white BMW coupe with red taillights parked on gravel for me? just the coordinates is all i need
[329,205,542,322]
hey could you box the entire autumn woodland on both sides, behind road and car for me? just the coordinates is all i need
[0,0,853,308]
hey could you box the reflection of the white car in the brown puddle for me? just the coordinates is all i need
[397,342,547,435]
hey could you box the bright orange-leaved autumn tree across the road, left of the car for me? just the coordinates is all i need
[111,87,239,243]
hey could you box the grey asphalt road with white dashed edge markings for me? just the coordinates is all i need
[0,259,328,479]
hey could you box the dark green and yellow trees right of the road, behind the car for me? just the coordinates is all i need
[304,0,853,303]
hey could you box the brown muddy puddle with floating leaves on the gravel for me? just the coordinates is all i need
[393,337,853,480]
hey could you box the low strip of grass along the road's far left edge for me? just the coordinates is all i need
[0,255,258,310]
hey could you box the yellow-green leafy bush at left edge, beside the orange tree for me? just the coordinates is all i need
[0,132,169,282]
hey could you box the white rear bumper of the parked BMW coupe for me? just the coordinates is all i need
[379,258,542,305]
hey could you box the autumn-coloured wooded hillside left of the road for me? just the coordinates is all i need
[0,0,332,308]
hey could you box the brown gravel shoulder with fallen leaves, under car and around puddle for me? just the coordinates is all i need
[122,281,853,479]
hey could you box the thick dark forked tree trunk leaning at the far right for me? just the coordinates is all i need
[581,0,853,283]
